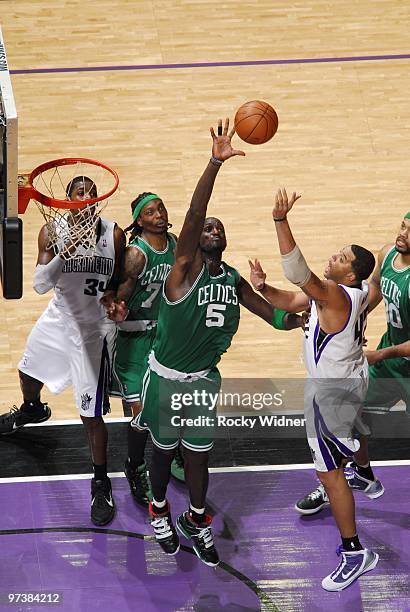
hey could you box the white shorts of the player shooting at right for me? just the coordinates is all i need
[304,378,370,472]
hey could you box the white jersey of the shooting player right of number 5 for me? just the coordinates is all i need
[304,282,369,379]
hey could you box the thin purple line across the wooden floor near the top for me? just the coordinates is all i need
[10,53,410,74]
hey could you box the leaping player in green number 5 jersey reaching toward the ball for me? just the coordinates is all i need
[134,119,300,566]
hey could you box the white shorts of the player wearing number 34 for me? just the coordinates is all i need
[18,301,117,417]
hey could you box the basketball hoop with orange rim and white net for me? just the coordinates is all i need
[29,161,115,259]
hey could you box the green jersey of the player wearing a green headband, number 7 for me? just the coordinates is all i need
[124,234,176,329]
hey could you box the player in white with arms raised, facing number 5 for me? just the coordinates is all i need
[250,189,379,591]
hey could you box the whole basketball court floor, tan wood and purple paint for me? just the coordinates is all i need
[0,0,410,612]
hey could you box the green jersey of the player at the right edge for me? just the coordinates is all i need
[380,247,410,346]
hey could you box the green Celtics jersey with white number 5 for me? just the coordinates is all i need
[153,263,240,372]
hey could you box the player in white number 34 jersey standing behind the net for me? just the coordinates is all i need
[0,176,125,525]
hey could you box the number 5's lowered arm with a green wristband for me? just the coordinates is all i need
[238,277,303,330]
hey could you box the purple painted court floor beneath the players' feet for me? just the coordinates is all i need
[0,465,410,612]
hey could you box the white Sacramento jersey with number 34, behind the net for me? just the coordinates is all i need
[52,219,115,323]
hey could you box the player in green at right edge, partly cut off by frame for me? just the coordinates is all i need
[295,212,410,514]
